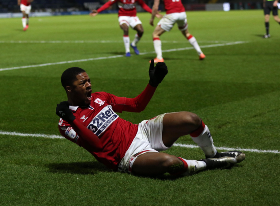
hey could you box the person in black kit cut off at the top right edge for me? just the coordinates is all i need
[263,0,280,39]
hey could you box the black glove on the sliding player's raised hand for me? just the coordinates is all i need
[149,59,168,87]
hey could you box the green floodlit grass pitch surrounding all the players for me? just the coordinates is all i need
[0,10,280,205]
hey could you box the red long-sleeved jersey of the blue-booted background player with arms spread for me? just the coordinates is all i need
[97,0,152,16]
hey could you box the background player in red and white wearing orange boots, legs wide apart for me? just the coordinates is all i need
[150,0,205,62]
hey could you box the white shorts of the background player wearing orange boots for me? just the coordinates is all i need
[157,12,188,31]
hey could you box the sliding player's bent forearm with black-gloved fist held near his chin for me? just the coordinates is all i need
[56,101,103,151]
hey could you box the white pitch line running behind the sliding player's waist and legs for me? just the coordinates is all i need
[0,130,280,154]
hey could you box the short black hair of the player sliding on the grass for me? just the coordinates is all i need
[61,67,85,89]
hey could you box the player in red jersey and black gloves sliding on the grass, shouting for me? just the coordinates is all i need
[56,60,245,176]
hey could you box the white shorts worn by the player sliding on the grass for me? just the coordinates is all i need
[118,114,169,173]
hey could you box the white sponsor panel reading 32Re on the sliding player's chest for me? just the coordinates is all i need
[87,105,119,136]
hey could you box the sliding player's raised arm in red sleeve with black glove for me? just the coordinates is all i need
[111,60,168,112]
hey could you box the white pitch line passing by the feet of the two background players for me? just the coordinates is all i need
[0,41,247,72]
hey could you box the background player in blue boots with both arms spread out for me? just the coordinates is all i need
[90,0,162,57]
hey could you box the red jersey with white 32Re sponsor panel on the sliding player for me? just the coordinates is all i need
[59,92,138,170]
